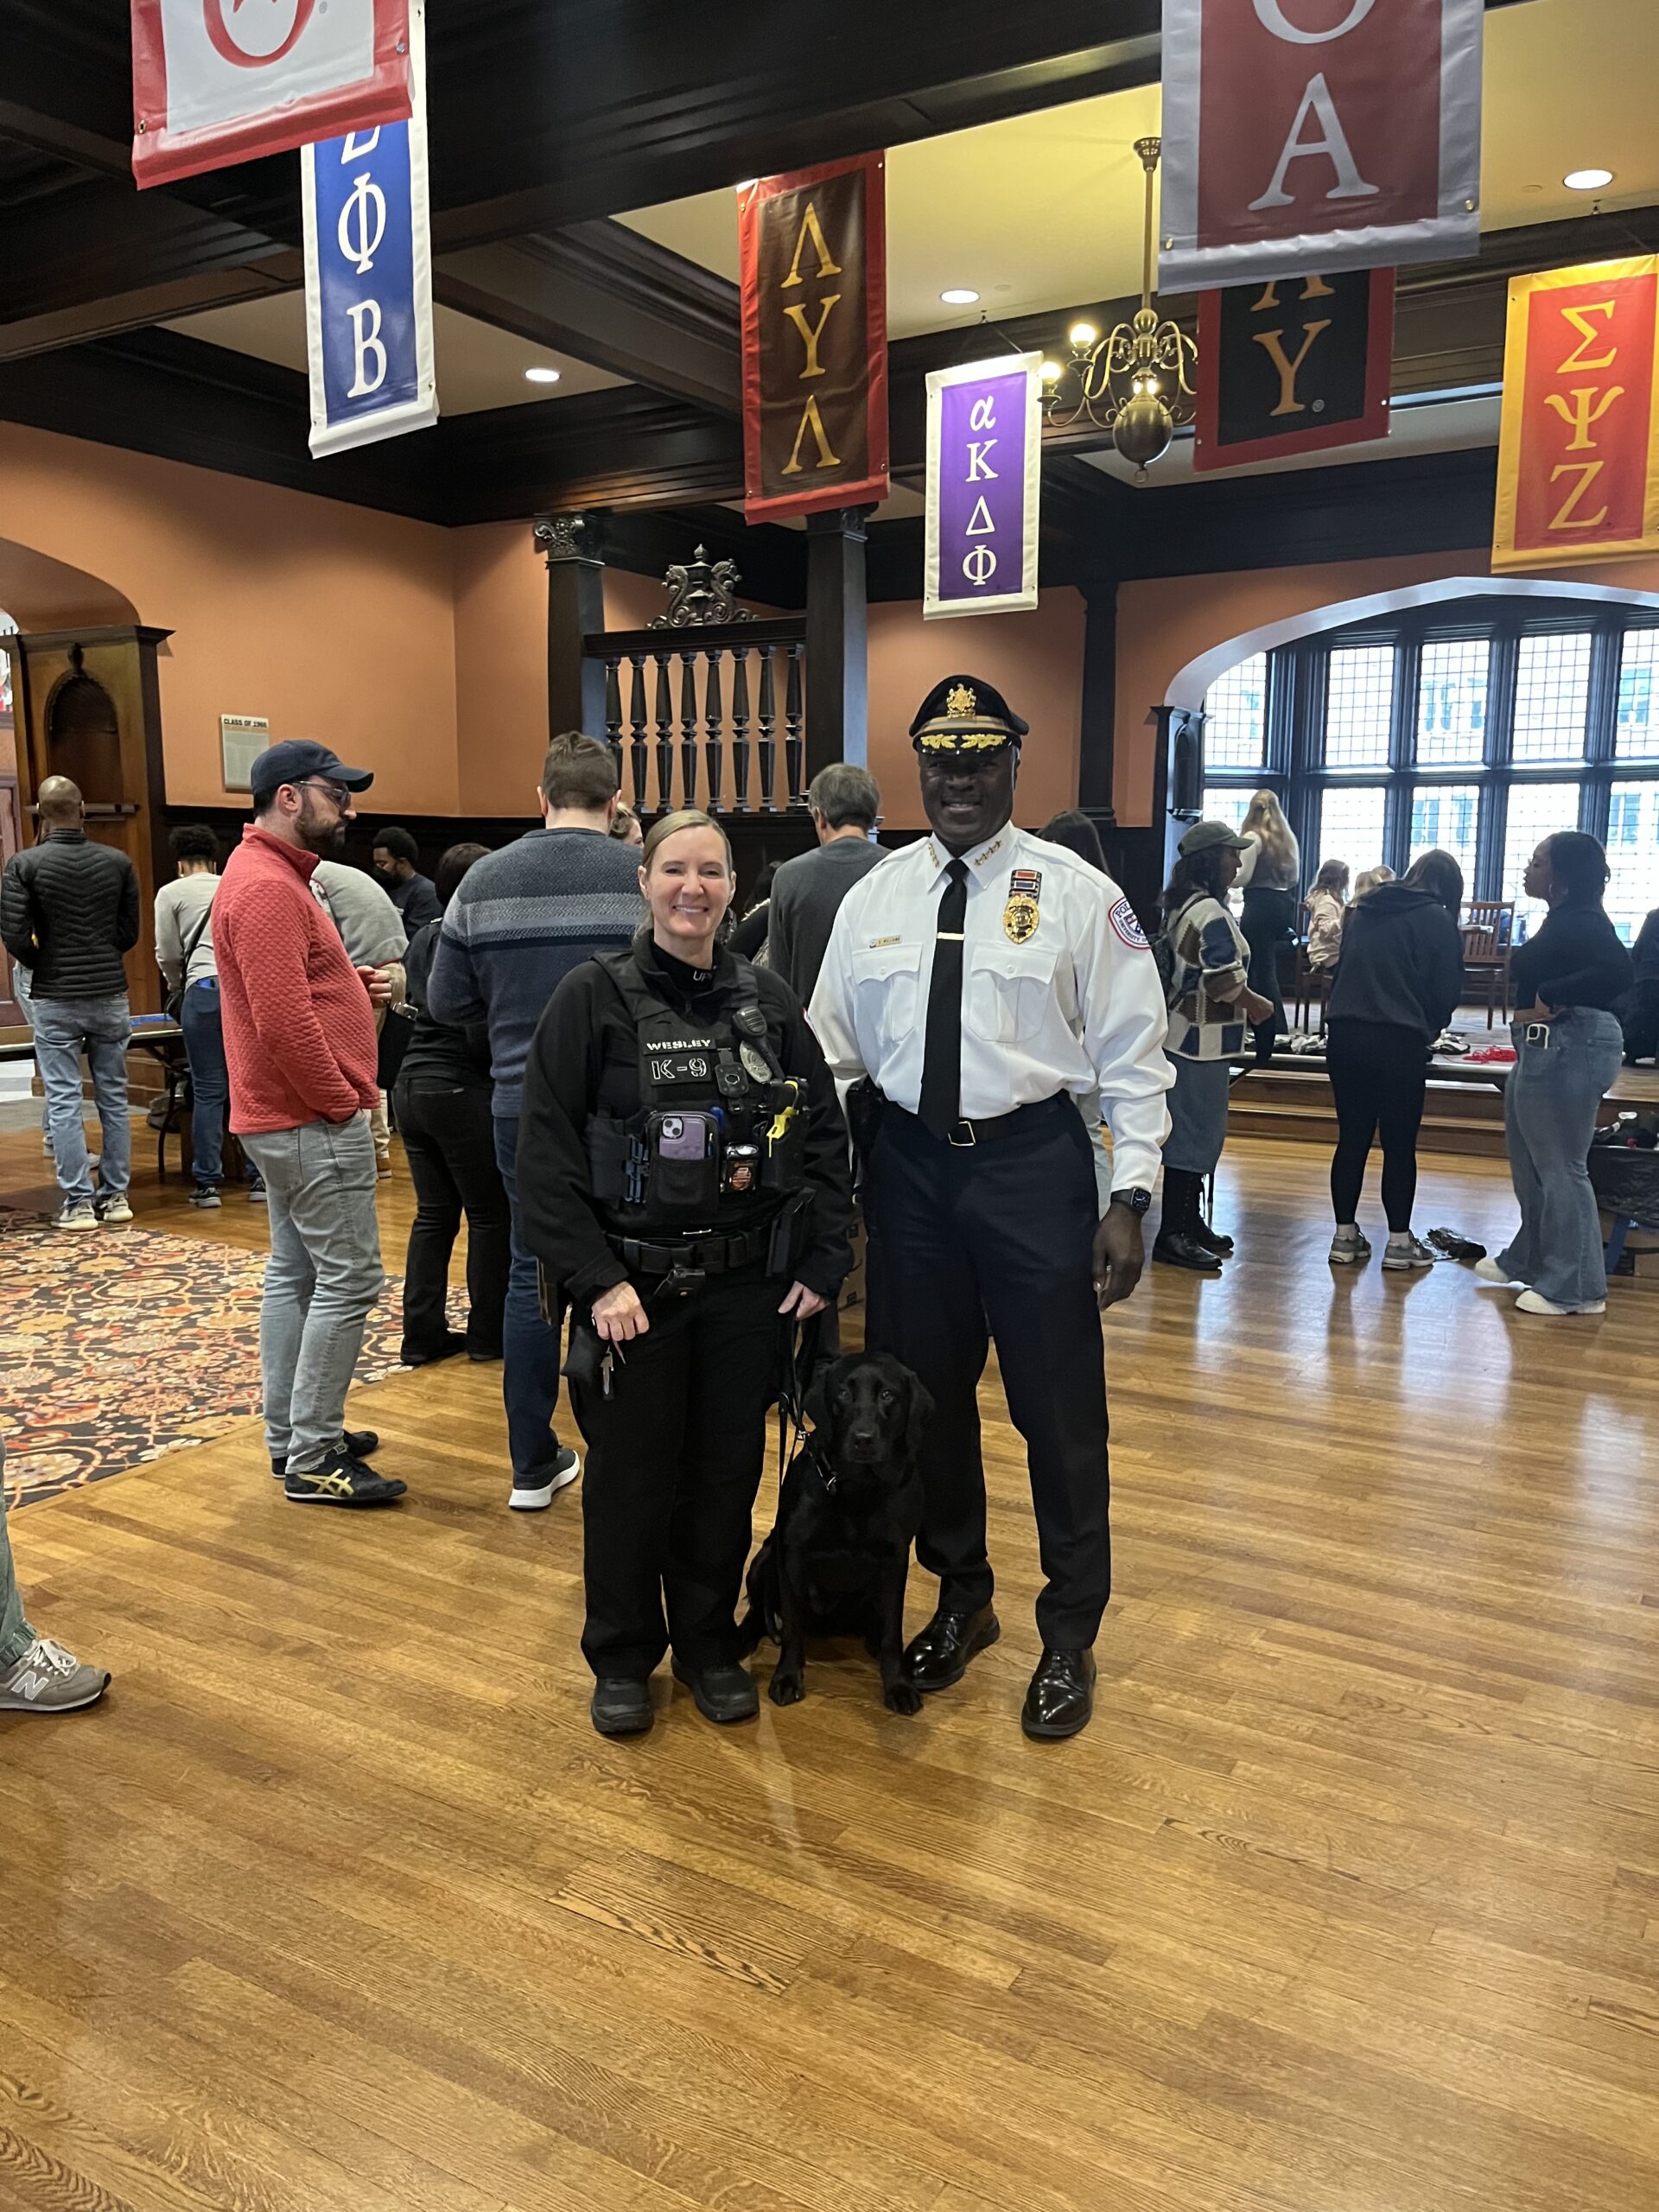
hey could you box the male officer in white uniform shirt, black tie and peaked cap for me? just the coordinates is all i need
[812,677,1173,1737]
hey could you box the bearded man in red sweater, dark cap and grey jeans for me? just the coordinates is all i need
[213,743,407,1506]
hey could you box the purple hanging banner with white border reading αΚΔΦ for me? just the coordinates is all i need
[923,354,1042,617]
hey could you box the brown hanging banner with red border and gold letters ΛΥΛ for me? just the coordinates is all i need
[736,153,887,522]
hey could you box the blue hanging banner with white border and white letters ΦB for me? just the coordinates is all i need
[301,0,438,458]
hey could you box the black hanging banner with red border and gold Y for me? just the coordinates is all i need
[1192,270,1394,471]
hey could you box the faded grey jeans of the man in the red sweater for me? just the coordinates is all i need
[241,1113,385,1473]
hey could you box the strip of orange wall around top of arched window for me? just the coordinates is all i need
[1113,546,1659,827]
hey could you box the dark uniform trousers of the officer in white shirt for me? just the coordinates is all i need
[865,1097,1113,1650]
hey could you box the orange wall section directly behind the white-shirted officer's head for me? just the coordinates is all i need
[869,584,1086,830]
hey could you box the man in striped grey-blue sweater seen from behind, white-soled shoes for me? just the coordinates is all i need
[427,730,644,1513]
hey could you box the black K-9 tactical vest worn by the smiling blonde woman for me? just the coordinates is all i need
[586,951,807,1239]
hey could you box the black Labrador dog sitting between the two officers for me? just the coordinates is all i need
[739,1351,933,1712]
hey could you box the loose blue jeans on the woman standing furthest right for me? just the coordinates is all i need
[1497,1007,1624,1305]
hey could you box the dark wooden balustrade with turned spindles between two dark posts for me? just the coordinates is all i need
[582,617,807,814]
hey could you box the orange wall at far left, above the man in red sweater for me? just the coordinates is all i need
[0,423,458,814]
